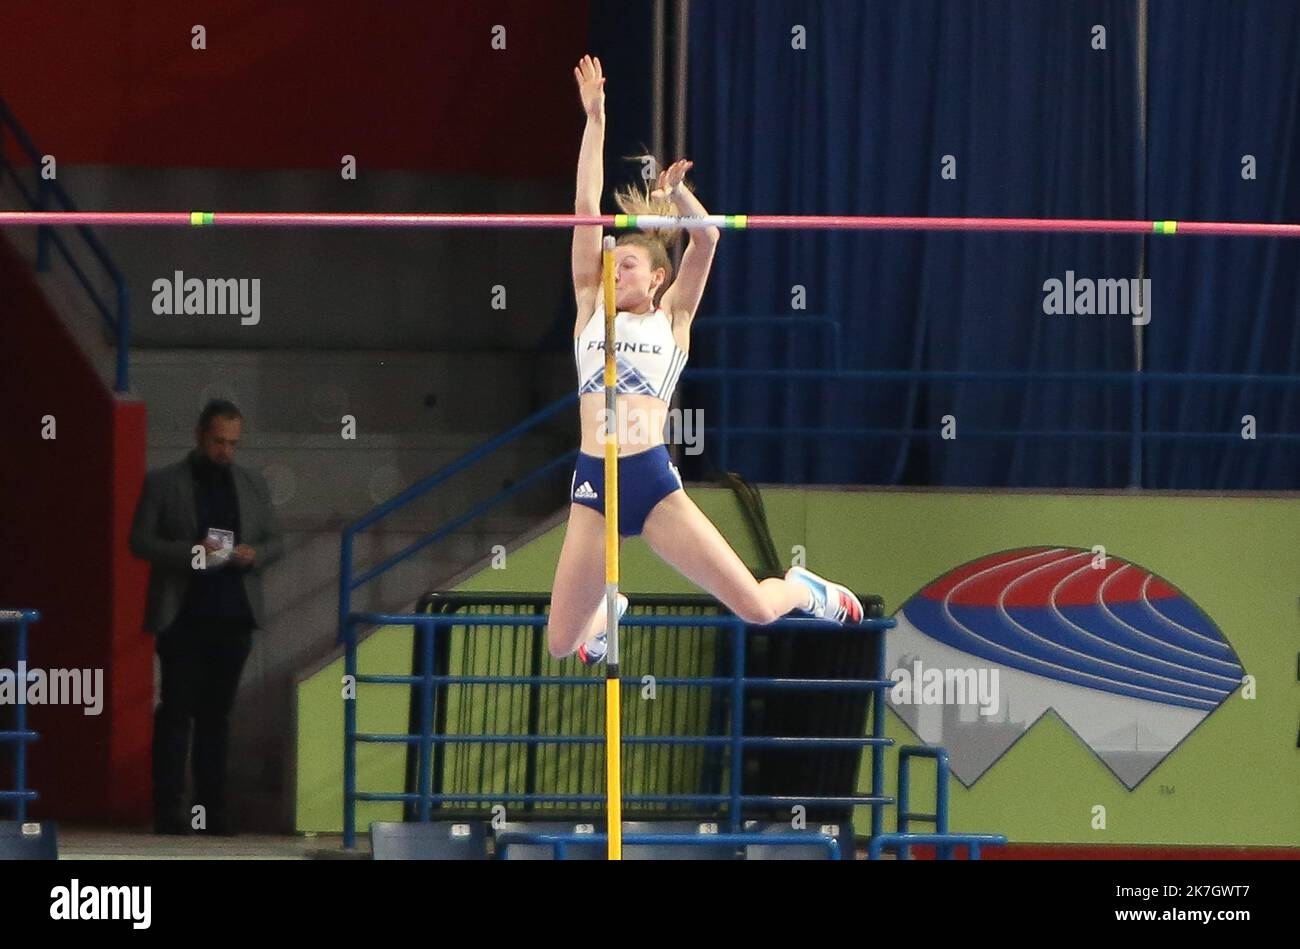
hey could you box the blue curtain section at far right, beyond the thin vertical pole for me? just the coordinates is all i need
[1145,0,1300,489]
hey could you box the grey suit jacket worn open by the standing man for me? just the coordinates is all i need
[131,452,285,634]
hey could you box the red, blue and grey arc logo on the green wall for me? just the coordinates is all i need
[887,547,1244,788]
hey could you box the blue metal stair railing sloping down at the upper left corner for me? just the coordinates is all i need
[0,99,131,393]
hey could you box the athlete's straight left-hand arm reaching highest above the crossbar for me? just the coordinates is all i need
[573,56,605,327]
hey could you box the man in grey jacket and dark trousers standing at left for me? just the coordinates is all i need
[131,400,283,836]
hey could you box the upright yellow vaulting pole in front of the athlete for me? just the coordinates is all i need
[602,237,623,861]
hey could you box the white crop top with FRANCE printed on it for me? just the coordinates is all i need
[573,302,686,402]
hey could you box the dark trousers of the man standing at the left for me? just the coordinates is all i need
[153,620,252,829]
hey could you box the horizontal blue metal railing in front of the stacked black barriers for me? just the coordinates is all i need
[343,612,894,848]
